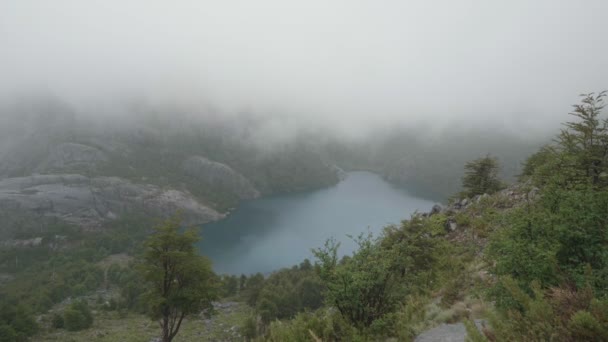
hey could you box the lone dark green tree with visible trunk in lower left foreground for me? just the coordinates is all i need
[140,216,217,342]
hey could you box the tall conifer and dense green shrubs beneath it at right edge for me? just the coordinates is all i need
[488,92,608,303]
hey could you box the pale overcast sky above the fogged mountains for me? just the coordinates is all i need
[0,0,608,134]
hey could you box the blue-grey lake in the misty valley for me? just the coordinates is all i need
[199,172,435,274]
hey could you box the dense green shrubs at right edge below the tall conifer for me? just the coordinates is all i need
[488,179,608,293]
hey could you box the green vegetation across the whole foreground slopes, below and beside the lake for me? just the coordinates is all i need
[0,93,608,341]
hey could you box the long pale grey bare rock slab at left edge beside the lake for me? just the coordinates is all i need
[0,174,223,234]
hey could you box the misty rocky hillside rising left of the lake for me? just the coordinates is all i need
[0,102,340,238]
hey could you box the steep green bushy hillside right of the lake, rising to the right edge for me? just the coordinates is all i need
[243,93,608,341]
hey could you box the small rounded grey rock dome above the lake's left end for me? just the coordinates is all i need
[182,156,260,199]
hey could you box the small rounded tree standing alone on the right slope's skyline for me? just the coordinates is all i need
[462,155,502,197]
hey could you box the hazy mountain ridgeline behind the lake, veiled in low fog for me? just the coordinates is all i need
[0,96,550,205]
